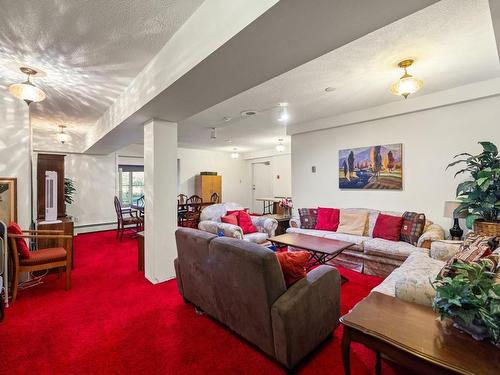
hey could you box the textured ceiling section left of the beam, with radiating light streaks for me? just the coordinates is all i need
[0,0,202,150]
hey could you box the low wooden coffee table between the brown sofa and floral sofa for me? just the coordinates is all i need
[269,233,354,274]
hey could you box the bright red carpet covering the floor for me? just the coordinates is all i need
[0,232,400,375]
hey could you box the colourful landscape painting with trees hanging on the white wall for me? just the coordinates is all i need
[339,143,403,190]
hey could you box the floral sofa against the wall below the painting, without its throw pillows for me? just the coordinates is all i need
[287,208,444,277]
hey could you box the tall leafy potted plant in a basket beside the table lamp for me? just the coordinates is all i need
[446,142,500,236]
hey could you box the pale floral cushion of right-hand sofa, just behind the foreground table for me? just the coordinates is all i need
[394,253,444,306]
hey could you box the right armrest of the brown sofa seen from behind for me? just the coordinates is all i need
[271,265,340,368]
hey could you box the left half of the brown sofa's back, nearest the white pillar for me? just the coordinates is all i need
[175,228,217,317]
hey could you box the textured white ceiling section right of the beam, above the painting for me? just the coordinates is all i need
[179,0,500,151]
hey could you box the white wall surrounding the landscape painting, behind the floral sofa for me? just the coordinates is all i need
[292,97,500,229]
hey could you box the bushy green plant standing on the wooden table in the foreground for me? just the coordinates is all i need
[432,259,500,346]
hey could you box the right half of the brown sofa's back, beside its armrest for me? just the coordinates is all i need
[209,237,286,356]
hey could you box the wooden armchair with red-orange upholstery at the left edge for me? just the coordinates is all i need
[8,230,73,302]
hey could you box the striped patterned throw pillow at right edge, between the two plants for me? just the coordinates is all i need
[439,232,499,277]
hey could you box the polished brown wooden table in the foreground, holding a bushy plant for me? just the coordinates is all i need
[340,292,500,375]
